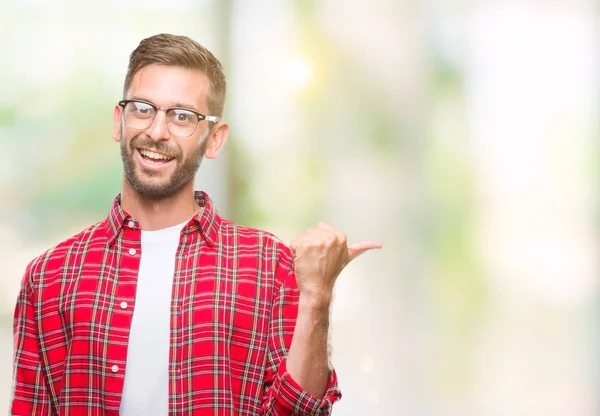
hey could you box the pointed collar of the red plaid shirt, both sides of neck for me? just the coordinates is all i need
[105,191,221,247]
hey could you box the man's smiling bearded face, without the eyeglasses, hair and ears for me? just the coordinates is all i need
[115,65,210,198]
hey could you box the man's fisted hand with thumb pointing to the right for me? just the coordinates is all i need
[290,222,383,302]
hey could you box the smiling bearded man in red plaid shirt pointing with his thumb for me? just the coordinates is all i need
[11,35,380,416]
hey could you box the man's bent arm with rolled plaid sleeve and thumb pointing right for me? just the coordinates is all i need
[261,223,381,415]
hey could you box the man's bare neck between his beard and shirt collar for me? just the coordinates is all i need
[121,179,198,231]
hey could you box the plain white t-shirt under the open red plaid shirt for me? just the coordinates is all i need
[119,221,187,416]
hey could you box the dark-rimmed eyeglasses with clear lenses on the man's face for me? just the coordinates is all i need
[119,100,220,137]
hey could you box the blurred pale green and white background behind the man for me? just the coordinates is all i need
[0,0,600,416]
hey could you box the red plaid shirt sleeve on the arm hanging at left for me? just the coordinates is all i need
[9,268,52,416]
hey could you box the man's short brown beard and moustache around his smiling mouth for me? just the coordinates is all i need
[120,129,210,199]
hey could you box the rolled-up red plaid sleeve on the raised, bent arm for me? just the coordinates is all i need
[259,249,342,416]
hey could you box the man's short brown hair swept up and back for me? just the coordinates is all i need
[123,33,226,117]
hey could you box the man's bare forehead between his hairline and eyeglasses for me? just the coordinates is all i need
[127,64,209,114]
